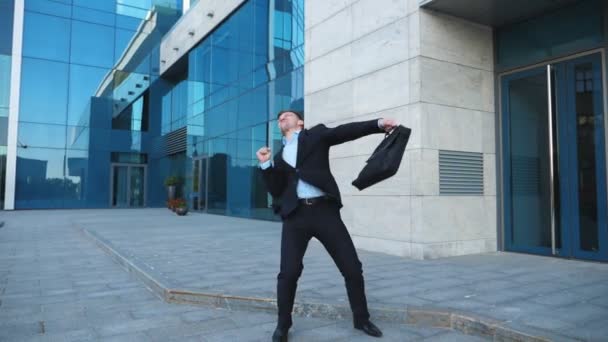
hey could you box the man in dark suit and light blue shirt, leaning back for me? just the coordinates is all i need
[257,110,397,341]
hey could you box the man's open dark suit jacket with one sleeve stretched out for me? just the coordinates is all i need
[262,119,384,219]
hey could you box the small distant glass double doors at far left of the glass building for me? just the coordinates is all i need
[110,164,146,208]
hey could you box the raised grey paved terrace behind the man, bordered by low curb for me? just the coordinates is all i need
[69,209,608,341]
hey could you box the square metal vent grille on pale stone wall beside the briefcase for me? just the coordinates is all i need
[439,150,483,195]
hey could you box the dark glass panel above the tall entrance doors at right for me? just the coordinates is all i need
[496,0,605,69]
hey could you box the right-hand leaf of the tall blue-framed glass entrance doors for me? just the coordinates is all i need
[562,54,608,260]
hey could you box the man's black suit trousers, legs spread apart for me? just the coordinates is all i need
[277,201,369,328]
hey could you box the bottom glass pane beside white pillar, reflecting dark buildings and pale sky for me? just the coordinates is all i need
[15,148,65,209]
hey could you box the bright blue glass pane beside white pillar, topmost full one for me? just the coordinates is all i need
[23,12,70,62]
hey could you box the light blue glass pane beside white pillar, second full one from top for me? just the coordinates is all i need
[19,58,69,124]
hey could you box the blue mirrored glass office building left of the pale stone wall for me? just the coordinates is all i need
[5,0,304,218]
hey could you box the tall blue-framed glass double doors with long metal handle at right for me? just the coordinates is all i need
[501,53,608,260]
